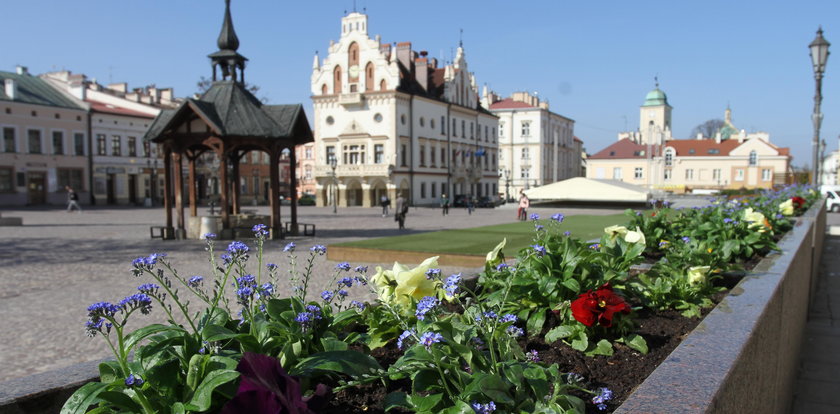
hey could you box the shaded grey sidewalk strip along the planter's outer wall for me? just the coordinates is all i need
[791,235,840,414]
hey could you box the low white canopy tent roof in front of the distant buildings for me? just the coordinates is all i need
[525,177,650,203]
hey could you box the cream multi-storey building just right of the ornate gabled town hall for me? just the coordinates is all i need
[482,88,582,199]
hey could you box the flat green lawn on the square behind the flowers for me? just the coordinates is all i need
[336,214,627,256]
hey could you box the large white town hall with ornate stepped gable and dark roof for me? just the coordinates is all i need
[304,12,498,206]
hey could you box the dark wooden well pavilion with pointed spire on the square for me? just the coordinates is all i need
[144,0,313,238]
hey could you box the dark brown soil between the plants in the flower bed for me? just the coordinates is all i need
[324,274,740,414]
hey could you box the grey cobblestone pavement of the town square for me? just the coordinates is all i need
[0,205,620,381]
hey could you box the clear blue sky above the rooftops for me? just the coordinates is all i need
[0,0,840,166]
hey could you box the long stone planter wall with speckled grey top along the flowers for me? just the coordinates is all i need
[616,203,825,414]
